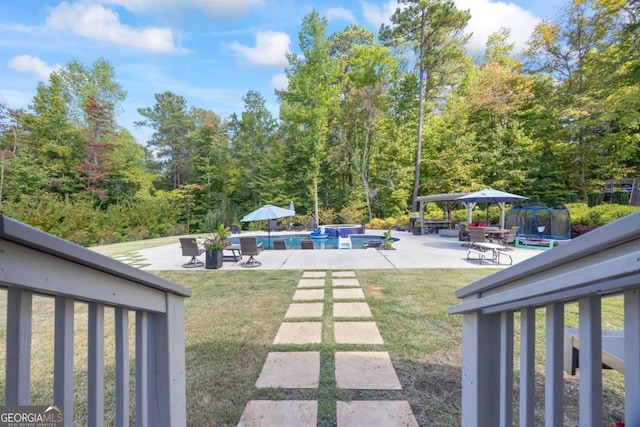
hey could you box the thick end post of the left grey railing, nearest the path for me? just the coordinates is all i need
[148,293,187,427]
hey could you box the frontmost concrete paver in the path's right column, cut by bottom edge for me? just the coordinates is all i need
[336,400,418,427]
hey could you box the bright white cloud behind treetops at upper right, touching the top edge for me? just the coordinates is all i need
[455,0,541,55]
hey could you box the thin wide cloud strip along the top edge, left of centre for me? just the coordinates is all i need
[99,0,263,18]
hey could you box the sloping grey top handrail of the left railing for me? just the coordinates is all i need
[0,215,191,297]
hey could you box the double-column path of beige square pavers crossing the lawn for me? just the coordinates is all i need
[238,271,418,427]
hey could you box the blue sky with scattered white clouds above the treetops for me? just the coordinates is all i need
[0,0,564,144]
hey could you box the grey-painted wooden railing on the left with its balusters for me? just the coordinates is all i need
[0,216,190,427]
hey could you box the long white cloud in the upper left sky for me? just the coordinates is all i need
[47,2,177,53]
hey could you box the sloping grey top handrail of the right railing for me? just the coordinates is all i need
[456,212,640,298]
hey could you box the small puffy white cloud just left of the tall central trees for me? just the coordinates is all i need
[229,31,291,67]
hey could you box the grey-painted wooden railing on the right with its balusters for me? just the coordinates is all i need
[449,213,640,427]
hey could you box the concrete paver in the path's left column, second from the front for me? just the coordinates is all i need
[256,351,320,388]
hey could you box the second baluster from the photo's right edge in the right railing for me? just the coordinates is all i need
[578,295,604,427]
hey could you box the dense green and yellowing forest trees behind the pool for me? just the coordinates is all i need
[0,0,640,245]
